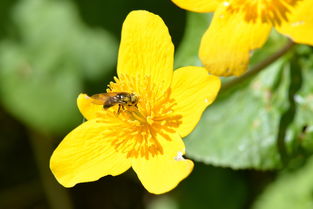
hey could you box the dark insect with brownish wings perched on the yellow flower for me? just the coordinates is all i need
[91,92,138,113]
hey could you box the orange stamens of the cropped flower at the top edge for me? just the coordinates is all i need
[223,0,302,26]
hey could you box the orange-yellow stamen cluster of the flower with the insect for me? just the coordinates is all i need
[98,78,181,159]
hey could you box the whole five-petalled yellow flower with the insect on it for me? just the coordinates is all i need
[50,11,220,194]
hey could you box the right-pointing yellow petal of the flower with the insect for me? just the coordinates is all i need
[171,67,221,137]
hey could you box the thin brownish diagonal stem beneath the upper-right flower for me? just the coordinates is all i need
[221,39,295,91]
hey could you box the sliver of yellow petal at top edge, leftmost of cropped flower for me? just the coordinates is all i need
[172,0,220,12]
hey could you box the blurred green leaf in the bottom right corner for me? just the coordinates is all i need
[253,157,313,209]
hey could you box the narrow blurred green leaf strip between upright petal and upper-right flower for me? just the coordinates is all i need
[175,12,212,68]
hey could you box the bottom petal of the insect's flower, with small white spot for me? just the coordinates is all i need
[132,133,193,194]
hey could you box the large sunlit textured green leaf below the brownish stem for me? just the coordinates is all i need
[185,60,289,169]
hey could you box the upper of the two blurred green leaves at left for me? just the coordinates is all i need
[13,0,117,80]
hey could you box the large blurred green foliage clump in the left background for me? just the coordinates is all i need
[0,0,117,133]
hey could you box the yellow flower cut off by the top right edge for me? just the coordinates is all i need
[172,0,313,76]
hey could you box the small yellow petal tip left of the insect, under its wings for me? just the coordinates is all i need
[77,94,103,120]
